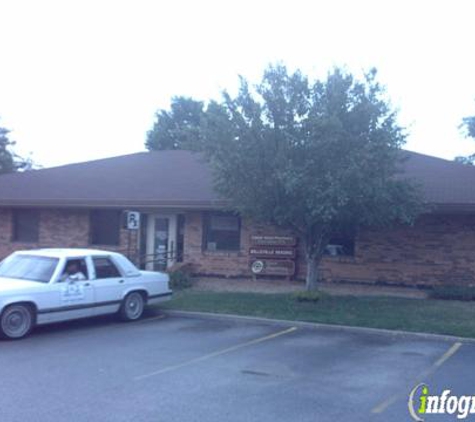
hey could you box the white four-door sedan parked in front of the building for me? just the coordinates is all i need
[0,249,172,339]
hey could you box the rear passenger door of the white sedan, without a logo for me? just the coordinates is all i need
[92,256,125,315]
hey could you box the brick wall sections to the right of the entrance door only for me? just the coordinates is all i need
[185,213,475,286]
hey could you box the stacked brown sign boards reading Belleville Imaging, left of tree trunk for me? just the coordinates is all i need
[249,235,297,278]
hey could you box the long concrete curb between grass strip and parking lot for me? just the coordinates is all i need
[163,309,475,343]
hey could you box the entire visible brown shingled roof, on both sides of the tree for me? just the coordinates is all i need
[0,151,475,211]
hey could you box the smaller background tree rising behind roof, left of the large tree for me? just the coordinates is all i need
[145,97,204,150]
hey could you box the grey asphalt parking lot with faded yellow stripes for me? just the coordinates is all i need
[0,314,475,422]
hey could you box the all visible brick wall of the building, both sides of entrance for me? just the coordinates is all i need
[0,209,475,286]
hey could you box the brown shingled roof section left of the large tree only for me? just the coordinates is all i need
[0,151,220,207]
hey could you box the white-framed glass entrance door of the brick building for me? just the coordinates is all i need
[146,214,177,271]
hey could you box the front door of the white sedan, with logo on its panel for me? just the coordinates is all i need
[38,257,94,322]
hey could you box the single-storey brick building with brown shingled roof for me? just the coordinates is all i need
[0,151,475,286]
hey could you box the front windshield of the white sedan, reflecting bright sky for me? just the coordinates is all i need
[0,255,59,283]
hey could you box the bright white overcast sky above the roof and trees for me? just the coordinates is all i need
[0,0,475,167]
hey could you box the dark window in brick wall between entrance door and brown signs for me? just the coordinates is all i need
[203,213,241,251]
